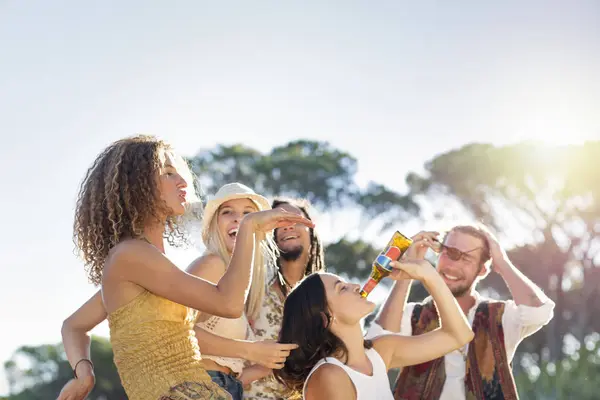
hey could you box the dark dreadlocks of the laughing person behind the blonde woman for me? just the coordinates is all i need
[271,197,325,296]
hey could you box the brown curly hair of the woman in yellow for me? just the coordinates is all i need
[73,135,195,285]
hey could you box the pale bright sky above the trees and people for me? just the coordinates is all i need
[0,0,600,394]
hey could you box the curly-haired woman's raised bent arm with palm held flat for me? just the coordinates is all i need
[110,209,313,318]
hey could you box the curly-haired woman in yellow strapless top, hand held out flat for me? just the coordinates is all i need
[59,136,312,400]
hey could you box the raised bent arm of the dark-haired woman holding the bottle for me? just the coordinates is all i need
[373,260,473,368]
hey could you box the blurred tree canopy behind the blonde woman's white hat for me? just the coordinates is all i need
[189,140,358,209]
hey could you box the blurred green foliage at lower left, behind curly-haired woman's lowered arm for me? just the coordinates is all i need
[4,337,127,400]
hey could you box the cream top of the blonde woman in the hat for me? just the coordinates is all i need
[196,313,252,374]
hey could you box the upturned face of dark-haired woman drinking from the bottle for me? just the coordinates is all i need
[319,273,375,325]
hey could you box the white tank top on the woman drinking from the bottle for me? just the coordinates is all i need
[302,349,394,400]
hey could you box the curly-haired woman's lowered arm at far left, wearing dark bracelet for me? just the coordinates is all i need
[58,291,106,400]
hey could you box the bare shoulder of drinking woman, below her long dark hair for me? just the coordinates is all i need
[304,364,356,400]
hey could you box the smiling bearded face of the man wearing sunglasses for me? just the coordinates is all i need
[437,230,488,297]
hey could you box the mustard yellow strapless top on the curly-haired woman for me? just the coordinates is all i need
[108,291,231,400]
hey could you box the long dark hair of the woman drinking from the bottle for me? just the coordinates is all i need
[273,273,372,398]
